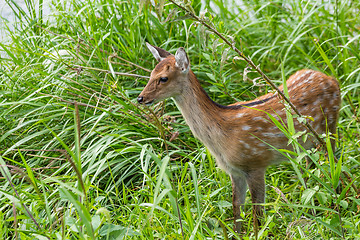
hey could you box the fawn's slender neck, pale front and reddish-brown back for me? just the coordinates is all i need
[174,71,224,144]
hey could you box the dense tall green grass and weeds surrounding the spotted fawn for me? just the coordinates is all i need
[0,0,360,239]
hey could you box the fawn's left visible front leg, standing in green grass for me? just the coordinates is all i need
[230,175,247,234]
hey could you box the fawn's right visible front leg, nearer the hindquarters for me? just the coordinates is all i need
[246,168,266,232]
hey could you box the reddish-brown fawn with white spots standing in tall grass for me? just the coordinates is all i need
[137,43,340,233]
